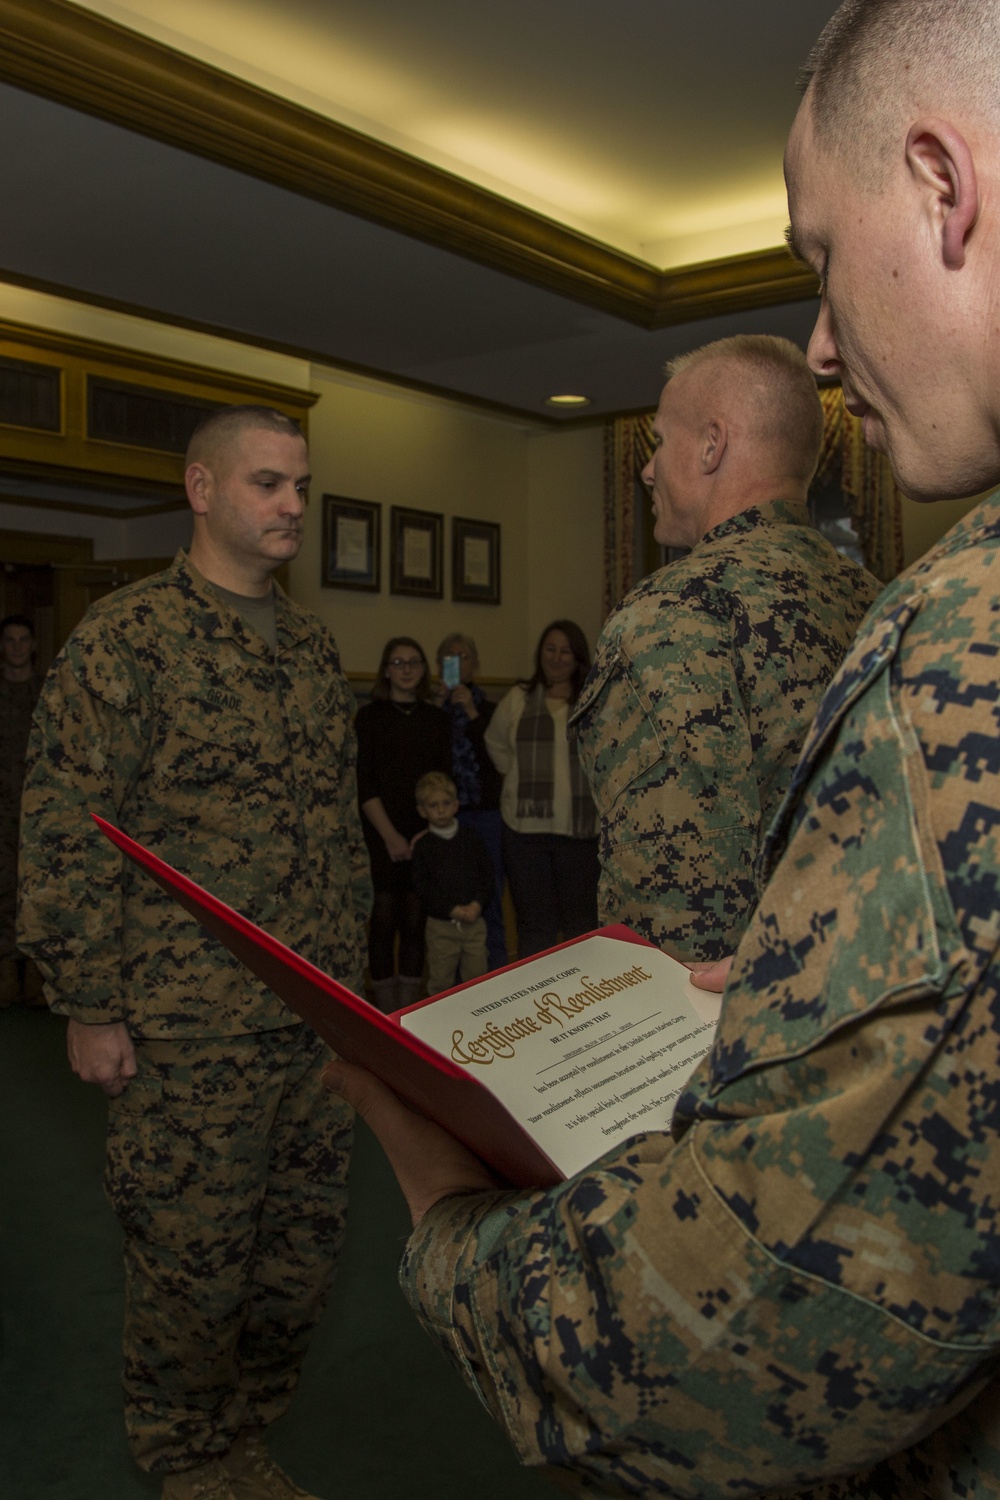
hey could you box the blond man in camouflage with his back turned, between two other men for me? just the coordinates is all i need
[570,335,880,960]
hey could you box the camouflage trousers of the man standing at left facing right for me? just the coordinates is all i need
[105,1026,351,1470]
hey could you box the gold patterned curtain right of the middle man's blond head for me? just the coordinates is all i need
[816,386,903,584]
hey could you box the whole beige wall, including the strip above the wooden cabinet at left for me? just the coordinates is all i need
[0,285,603,678]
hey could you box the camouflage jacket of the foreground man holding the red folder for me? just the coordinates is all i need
[402,537,1000,1500]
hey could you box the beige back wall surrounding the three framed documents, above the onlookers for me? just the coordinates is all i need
[292,368,603,677]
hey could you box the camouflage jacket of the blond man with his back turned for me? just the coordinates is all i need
[573,471,879,960]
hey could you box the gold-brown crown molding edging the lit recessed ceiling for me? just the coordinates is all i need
[0,0,816,329]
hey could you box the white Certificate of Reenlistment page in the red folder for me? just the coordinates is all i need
[399,936,721,1178]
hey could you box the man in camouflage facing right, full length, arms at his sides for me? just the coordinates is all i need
[21,405,372,1496]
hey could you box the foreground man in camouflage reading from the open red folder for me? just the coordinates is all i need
[320,0,1000,1500]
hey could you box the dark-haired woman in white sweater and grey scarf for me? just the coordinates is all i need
[486,620,598,959]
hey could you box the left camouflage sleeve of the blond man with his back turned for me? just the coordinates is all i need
[574,578,762,960]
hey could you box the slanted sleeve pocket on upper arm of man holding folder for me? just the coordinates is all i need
[712,662,964,1091]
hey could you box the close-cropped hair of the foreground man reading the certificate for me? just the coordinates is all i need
[799,0,1000,171]
